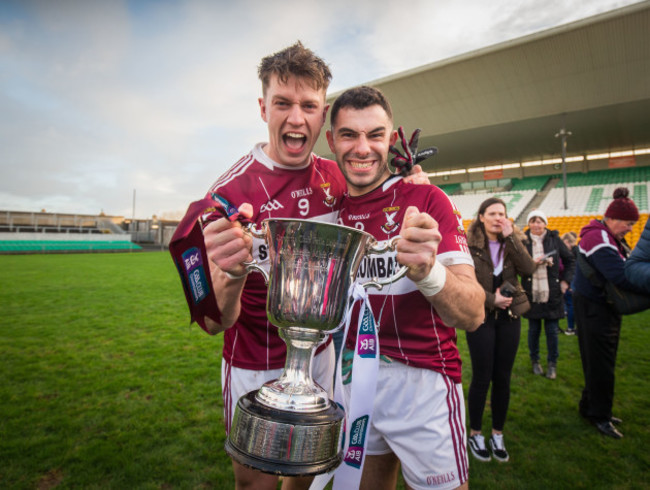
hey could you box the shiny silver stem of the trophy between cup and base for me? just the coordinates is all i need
[255,327,330,413]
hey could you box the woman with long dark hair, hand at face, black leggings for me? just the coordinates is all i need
[466,197,536,462]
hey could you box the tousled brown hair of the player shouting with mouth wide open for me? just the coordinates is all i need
[257,41,332,95]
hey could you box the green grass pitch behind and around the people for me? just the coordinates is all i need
[0,252,650,490]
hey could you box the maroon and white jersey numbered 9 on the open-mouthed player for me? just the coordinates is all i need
[208,143,346,370]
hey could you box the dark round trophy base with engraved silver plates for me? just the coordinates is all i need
[226,391,344,476]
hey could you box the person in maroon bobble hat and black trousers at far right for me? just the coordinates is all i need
[572,187,639,439]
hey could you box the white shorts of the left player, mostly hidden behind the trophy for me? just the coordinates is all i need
[221,342,336,434]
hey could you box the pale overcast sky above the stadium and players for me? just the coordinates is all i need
[0,0,637,218]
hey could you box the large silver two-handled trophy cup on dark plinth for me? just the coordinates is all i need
[226,219,407,476]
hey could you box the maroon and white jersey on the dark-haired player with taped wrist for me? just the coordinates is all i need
[340,177,474,383]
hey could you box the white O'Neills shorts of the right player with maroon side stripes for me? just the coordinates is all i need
[345,360,468,490]
